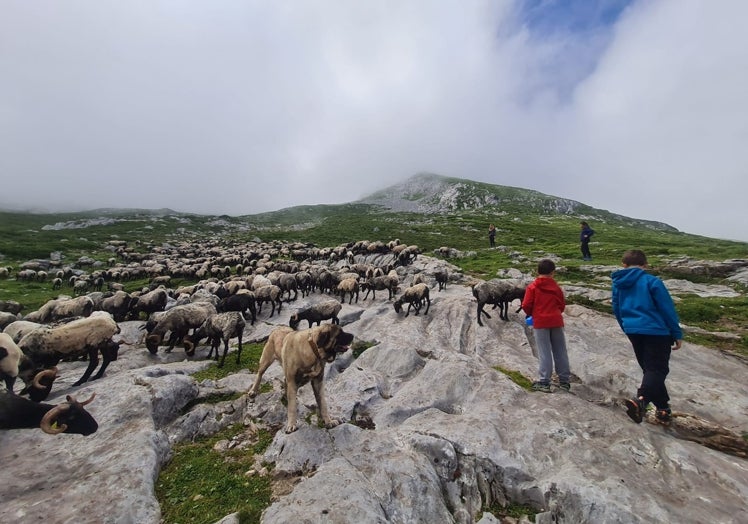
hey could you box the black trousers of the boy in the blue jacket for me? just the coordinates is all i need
[628,335,673,409]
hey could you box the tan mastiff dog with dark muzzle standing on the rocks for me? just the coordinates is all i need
[248,324,353,433]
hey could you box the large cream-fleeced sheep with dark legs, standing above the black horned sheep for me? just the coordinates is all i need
[18,311,120,386]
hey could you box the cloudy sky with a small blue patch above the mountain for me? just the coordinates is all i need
[0,0,748,241]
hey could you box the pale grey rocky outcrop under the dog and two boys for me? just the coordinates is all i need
[0,256,748,524]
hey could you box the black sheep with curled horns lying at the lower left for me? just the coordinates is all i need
[0,394,99,436]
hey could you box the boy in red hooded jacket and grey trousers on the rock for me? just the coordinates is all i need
[522,258,571,393]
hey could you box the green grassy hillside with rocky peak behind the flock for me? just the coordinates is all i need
[0,175,748,349]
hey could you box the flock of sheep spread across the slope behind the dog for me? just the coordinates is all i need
[0,240,524,434]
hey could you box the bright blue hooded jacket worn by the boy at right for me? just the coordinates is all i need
[611,267,683,340]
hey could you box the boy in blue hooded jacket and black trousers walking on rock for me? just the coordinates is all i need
[611,249,683,424]
